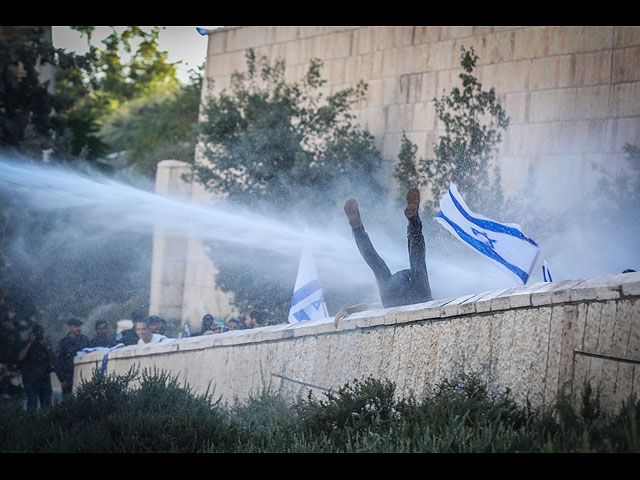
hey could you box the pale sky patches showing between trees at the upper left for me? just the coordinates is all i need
[52,25,218,82]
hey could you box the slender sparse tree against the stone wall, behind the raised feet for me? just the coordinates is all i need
[394,46,509,213]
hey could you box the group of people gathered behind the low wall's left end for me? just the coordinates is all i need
[18,311,269,410]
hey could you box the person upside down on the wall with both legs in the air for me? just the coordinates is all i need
[334,187,432,328]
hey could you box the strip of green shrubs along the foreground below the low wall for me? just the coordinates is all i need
[0,371,640,453]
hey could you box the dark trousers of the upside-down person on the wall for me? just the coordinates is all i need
[353,215,431,308]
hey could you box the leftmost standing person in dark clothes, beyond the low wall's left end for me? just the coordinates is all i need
[18,324,56,410]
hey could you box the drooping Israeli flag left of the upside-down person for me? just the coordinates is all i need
[289,249,329,323]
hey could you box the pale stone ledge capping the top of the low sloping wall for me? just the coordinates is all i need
[75,272,640,364]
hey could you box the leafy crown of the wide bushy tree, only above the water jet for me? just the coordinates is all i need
[193,50,381,213]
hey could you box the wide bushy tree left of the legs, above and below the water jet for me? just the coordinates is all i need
[192,50,385,318]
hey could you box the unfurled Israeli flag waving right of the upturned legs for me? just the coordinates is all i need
[435,183,538,285]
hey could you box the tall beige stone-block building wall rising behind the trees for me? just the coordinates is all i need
[203,26,640,205]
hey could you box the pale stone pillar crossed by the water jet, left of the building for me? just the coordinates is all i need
[149,160,191,319]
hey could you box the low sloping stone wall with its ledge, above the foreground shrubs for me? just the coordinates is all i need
[74,273,640,418]
